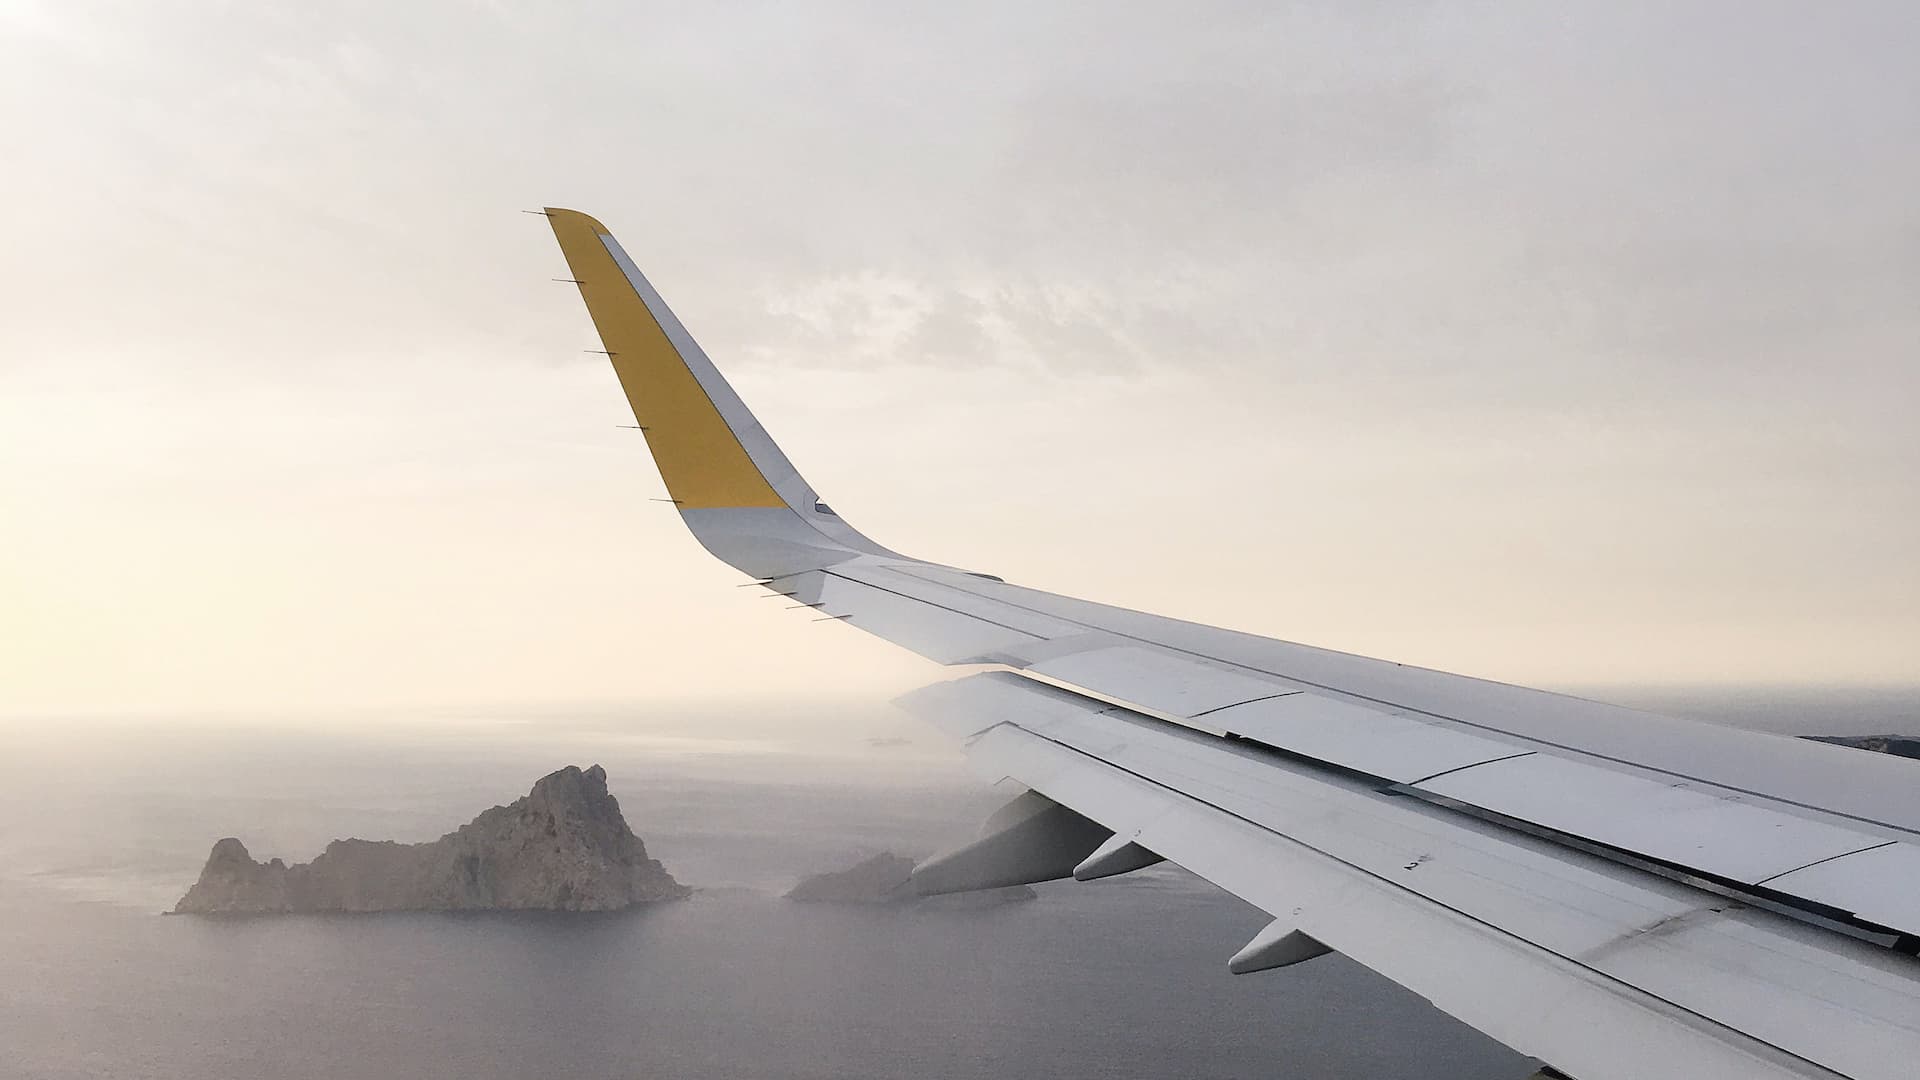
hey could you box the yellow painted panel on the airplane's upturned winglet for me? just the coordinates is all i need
[547,206,787,509]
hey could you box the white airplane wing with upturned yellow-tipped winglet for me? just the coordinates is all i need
[545,208,1920,1080]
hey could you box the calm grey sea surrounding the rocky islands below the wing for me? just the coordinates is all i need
[0,688,1920,1080]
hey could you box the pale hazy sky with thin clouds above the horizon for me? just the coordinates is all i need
[0,0,1920,715]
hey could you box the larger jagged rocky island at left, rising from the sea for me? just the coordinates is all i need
[173,765,691,915]
